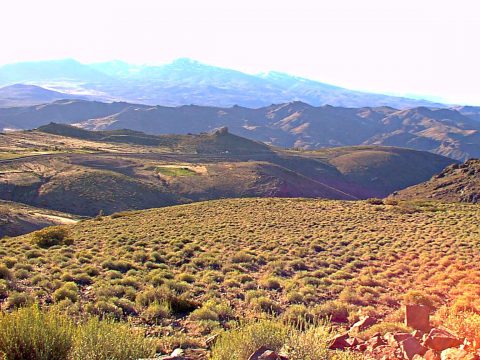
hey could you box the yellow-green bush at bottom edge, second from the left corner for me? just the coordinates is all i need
[71,318,155,360]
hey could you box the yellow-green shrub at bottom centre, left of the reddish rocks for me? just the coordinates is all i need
[212,320,287,360]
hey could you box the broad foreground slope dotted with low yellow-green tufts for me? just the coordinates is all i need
[0,199,480,359]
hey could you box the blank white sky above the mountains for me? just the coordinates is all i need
[0,0,480,105]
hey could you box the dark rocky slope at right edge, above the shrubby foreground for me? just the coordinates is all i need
[392,159,480,203]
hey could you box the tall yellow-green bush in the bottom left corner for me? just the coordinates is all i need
[0,306,74,360]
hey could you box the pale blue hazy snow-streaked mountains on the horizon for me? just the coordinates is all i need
[0,59,448,109]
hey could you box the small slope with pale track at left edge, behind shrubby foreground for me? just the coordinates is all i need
[0,200,79,238]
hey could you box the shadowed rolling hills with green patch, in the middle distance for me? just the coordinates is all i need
[0,124,454,216]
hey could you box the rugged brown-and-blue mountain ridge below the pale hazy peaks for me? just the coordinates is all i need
[0,100,480,160]
